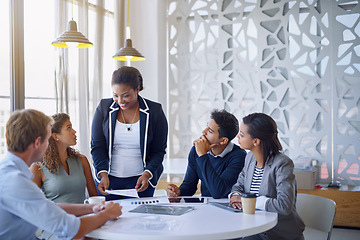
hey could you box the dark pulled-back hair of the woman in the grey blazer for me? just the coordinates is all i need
[243,113,282,161]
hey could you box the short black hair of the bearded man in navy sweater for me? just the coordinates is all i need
[210,109,239,142]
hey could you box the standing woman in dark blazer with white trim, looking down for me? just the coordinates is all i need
[91,66,168,200]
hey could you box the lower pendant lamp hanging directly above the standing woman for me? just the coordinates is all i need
[112,0,145,61]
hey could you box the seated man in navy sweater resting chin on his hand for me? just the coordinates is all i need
[166,109,246,198]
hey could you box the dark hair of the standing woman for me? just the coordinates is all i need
[111,66,143,91]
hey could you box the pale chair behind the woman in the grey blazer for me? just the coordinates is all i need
[296,193,336,240]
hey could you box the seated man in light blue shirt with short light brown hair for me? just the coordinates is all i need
[0,110,121,239]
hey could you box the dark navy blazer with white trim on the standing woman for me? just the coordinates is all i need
[91,96,168,187]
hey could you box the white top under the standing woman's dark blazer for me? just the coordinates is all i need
[110,120,144,178]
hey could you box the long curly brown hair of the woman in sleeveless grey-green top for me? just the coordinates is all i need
[39,113,80,173]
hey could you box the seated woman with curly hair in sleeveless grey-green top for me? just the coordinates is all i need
[30,113,98,203]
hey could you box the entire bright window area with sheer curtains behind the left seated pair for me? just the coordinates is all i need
[0,0,116,162]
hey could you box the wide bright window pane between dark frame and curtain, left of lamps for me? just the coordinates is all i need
[24,0,56,115]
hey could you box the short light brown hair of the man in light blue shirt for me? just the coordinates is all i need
[5,109,53,153]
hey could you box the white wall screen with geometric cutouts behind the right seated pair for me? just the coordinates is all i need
[168,0,360,185]
